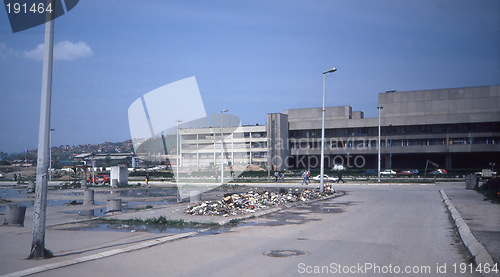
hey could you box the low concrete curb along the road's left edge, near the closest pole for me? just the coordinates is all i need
[0,230,199,277]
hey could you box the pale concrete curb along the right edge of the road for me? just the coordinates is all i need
[439,189,495,276]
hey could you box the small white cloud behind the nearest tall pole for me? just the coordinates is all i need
[24,40,94,61]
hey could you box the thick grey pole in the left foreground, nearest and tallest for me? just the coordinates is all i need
[28,0,55,259]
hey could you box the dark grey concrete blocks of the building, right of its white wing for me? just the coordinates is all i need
[267,85,500,169]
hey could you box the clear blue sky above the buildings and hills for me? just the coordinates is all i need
[0,0,500,153]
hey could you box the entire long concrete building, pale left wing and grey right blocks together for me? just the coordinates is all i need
[136,85,500,170]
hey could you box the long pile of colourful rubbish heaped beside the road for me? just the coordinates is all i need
[185,185,335,216]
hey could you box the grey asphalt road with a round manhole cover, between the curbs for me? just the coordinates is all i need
[36,185,479,276]
